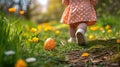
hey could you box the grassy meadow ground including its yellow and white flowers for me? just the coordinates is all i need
[0,14,120,67]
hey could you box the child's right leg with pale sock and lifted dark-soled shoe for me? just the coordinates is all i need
[75,23,87,45]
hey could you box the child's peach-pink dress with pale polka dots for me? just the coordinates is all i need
[61,0,97,25]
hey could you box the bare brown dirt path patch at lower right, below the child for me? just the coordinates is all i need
[66,49,120,67]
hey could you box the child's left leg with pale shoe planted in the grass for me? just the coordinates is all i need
[68,24,77,42]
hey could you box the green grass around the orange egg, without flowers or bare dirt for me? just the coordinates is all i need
[0,15,120,67]
